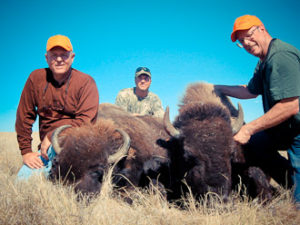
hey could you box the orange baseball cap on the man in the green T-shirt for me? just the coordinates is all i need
[231,15,263,42]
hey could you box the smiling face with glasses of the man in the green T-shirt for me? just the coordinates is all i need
[236,26,264,58]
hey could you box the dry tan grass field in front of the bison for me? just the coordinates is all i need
[0,133,300,225]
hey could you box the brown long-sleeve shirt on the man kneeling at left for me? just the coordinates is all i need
[15,68,99,155]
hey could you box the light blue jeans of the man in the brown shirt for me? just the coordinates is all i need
[17,145,56,180]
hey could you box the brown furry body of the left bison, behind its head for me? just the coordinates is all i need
[98,103,169,186]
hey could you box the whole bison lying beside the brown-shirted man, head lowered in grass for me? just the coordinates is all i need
[50,103,171,197]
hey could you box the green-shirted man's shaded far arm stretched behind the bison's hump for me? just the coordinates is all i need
[214,85,257,99]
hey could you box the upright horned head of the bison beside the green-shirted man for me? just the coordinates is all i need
[164,84,244,197]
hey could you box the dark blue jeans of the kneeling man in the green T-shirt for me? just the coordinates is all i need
[245,131,300,206]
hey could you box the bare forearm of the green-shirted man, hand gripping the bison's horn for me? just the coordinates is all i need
[234,97,299,144]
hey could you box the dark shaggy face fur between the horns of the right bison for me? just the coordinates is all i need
[174,94,234,200]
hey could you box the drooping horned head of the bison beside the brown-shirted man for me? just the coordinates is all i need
[50,120,130,194]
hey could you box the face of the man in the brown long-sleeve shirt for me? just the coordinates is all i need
[46,47,75,75]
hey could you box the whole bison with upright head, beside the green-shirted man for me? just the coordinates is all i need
[161,83,272,199]
